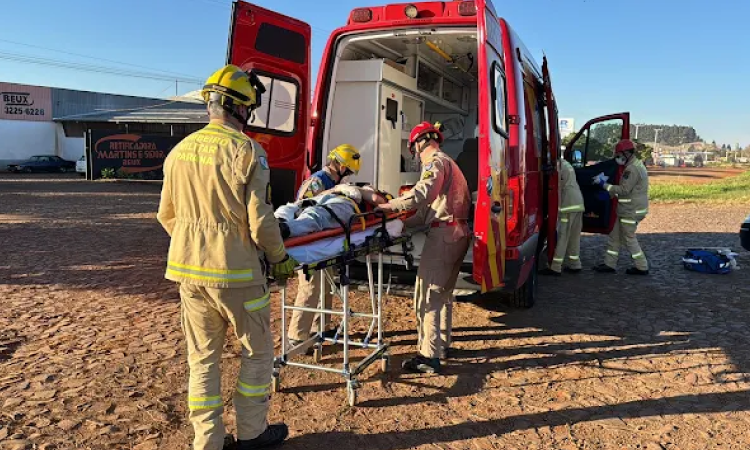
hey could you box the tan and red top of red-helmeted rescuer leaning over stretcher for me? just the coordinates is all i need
[389,151,471,239]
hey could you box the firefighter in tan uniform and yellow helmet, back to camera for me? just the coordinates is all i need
[157,65,296,450]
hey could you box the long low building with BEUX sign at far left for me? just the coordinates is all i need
[0,82,208,170]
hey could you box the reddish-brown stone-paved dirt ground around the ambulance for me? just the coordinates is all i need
[0,176,750,450]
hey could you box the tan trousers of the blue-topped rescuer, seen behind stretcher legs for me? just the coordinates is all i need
[287,269,333,341]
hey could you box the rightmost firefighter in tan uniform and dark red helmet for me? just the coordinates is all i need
[594,139,648,275]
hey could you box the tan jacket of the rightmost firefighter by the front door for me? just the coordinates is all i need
[604,158,648,221]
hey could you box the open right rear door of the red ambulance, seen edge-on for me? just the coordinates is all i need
[472,0,508,293]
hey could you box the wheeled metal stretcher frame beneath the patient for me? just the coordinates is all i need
[272,211,422,407]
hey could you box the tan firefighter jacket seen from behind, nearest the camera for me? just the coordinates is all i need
[157,121,286,288]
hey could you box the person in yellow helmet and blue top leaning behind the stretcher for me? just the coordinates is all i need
[287,144,360,346]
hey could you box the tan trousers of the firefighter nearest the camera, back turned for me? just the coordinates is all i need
[180,284,274,450]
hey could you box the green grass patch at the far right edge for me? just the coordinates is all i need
[649,172,750,202]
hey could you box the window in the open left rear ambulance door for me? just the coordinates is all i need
[247,75,299,135]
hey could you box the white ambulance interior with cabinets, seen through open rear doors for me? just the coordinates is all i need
[323,28,479,268]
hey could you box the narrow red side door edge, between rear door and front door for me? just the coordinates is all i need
[542,56,560,264]
